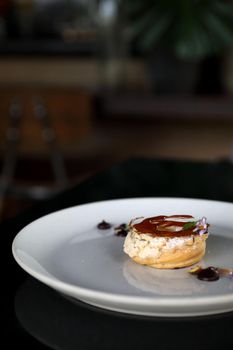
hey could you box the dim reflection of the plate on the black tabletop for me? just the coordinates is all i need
[15,277,233,350]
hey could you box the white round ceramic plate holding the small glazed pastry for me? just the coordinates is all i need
[12,198,233,317]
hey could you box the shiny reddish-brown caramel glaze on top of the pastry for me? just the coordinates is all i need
[131,215,198,237]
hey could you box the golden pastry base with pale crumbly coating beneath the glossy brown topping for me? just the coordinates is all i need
[124,219,208,269]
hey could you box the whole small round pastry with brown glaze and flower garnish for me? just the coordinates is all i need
[124,215,209,269]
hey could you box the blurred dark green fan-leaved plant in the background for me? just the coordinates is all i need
[123,0,233,60]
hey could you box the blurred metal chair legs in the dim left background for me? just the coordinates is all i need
[0,97,68,219]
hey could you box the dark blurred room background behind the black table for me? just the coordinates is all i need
[0,0,233,220]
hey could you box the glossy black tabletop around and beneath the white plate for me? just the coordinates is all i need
[0,159,233,350]
